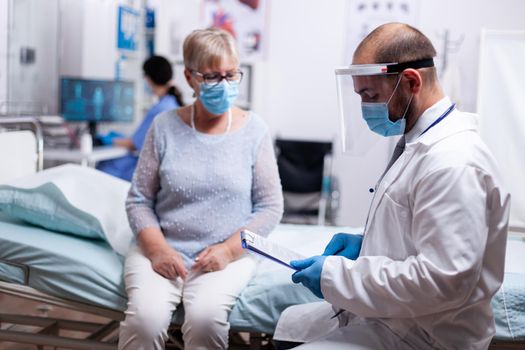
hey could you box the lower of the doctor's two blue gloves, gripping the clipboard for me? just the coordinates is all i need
[290,255,326,299]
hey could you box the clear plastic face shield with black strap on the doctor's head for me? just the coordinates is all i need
[335,59,434,155]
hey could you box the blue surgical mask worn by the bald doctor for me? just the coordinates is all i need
[361,77,413,136]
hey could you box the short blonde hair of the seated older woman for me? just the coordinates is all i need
[182,28,239,71]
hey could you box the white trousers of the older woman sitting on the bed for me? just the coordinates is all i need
[118,247,256,350]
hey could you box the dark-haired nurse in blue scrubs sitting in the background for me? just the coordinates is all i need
[97,56,184,181]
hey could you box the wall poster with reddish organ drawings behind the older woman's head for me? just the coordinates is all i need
[201,0,269,60]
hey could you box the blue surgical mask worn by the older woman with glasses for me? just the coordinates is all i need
[199,80,239,115]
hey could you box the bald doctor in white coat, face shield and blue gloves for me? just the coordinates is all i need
[274,23,510,350]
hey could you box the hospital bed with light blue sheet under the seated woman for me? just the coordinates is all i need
[0,121,525,349]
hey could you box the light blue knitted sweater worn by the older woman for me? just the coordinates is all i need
[126,110,283,267]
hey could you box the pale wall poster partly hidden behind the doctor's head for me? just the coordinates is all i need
[344,0,419,63]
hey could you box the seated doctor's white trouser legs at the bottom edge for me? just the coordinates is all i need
[273,301,434,350]
